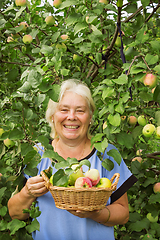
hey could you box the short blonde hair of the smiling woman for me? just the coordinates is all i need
[46,79,95,139]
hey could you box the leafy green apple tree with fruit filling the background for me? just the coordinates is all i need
[0,0,160,240]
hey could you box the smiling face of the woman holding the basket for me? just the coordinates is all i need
[53,91,92,140]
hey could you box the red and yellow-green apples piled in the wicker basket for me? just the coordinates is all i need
[49,164,112,188]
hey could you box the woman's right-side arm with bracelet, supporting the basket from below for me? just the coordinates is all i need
[70,193,129,227]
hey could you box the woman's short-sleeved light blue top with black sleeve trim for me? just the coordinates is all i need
[26,144,137,240]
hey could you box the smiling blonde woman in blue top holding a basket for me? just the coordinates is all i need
[8,80,136,240]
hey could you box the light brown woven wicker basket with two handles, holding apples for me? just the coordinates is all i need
[41,171,120,211]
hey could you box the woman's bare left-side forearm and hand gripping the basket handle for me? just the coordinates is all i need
[8,176,48,220]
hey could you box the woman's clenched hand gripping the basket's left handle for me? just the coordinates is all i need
[25,176,48,198]
